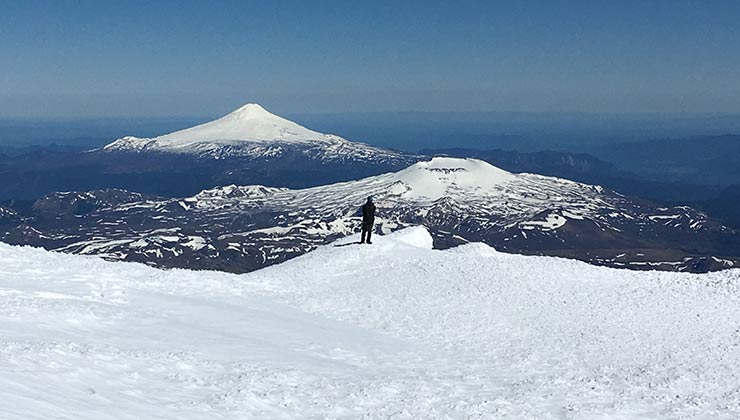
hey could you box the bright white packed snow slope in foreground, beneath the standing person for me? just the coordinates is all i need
[0,228,740,420]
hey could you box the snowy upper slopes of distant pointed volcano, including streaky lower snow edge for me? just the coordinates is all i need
[102,103,408,160]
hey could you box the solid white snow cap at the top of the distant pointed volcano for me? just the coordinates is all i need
[148,103,329,147]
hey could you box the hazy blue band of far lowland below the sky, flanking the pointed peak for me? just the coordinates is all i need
[0,110,740,152]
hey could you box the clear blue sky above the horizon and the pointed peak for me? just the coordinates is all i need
[0,0,740,117]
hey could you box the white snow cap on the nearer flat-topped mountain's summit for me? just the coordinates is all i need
[396,157,516,199]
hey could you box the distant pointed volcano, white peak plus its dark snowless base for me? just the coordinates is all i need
[0,103,421,200]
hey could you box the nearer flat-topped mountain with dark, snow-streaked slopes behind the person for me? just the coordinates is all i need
[3,158,740,272]
